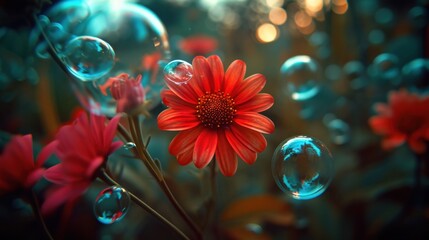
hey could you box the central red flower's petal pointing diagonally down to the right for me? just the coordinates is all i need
[231,124,267,152]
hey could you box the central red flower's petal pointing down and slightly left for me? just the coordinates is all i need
[192,128,217,168]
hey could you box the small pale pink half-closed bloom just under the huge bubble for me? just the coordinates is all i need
[100,73,145,113]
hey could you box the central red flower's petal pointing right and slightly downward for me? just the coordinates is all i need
[234,112,274,133]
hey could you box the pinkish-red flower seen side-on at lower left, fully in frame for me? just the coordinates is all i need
[42,111,122,213]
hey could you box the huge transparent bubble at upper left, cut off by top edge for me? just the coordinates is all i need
[35,1,170,116]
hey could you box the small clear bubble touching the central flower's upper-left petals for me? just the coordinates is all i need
[164,60,193,85]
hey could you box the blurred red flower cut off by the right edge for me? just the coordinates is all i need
[369,90,429,153]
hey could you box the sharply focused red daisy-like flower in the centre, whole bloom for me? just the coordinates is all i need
[158,56,274,176]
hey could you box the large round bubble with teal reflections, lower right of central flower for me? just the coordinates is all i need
[271,136,333,200]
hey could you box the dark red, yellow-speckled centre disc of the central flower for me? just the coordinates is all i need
[195,91,237,128]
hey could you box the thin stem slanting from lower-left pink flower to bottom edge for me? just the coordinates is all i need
[99,170,190,240]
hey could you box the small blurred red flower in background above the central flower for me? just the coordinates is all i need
[179,35,217,56]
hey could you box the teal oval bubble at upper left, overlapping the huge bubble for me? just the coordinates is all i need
[63,36,115,81]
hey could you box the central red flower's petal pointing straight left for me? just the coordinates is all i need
[158,109,200,131]
